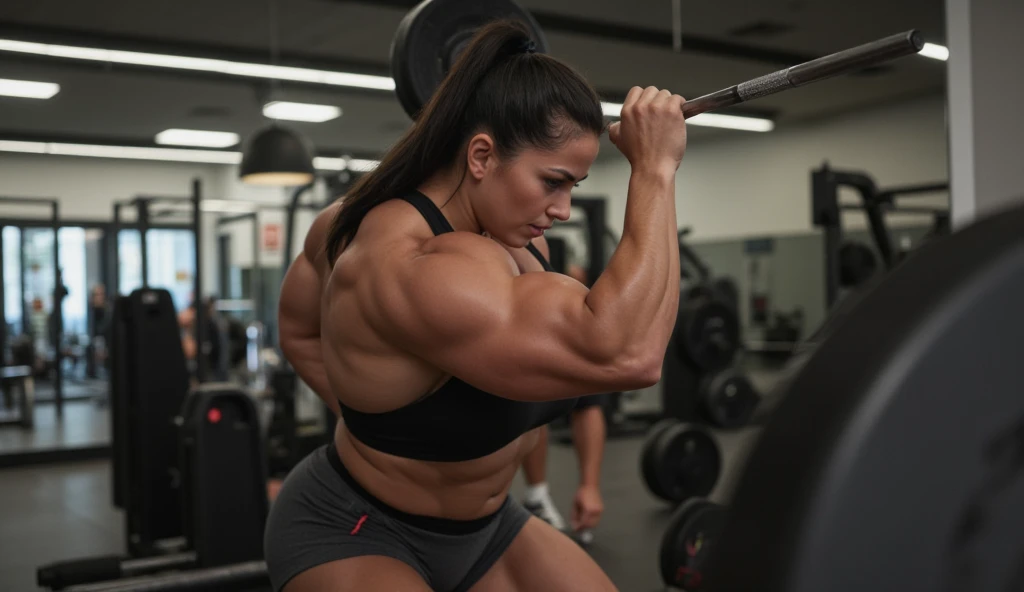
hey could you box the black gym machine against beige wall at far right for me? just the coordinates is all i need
[811,163,950,310]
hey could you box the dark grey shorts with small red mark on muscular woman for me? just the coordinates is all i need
[263,443,531,592]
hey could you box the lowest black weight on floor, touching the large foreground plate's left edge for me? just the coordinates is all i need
[659,499,725,592]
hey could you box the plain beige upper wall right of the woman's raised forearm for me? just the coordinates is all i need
[578,93,948,242]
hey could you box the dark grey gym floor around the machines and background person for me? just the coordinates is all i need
[0,428,758,592]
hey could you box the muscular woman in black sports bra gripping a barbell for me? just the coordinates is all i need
[265,18,686,592]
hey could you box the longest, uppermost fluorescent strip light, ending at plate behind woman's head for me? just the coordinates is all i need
[0,39,394,90]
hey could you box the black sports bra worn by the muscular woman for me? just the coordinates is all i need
[339,192,577,462]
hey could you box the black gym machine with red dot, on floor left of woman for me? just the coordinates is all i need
[37,168,364,592]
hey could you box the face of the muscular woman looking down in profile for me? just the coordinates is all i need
[470,133,600,248]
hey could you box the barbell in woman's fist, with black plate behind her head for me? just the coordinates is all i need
[391,0,925,119]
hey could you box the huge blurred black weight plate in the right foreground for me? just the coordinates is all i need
[705,203,1024,592]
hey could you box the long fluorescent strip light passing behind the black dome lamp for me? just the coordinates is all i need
[0,140,380,172]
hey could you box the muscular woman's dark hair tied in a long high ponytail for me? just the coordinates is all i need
[325,20,604,262]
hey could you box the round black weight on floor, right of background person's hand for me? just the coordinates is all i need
[650,423,722,503]
